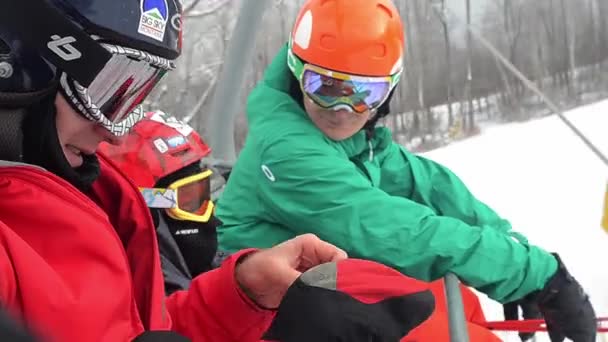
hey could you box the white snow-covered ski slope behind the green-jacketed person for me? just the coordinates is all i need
[423,100,608,341]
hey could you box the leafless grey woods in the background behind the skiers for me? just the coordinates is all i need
[146,0,608,152]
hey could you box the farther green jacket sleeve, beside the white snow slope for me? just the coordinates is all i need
[380,142,525,235]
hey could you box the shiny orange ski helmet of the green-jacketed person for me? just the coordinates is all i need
[290,0,405,76]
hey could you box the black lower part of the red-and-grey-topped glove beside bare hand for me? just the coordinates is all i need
[263,280,435,342]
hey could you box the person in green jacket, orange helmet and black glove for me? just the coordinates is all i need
[217,0,596,342]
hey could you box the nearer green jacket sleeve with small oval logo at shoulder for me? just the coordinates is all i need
[257,134,557,302]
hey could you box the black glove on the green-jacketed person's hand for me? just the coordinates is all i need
[533,254,597,342]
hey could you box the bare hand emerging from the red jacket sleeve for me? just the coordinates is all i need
[235,234,347,309]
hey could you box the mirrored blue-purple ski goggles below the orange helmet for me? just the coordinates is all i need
[287,49,402,113]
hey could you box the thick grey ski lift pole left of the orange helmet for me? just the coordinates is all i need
[206,0,269,165]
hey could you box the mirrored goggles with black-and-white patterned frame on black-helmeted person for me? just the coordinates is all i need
[60,43,175,136]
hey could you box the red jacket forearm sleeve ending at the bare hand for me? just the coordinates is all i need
[167,249,274,342]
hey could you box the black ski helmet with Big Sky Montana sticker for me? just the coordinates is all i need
[0,0,182,93]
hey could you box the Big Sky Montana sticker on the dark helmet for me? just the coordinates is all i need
[137,0,169,42]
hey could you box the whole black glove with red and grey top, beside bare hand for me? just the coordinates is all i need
[262,259,435,342]
